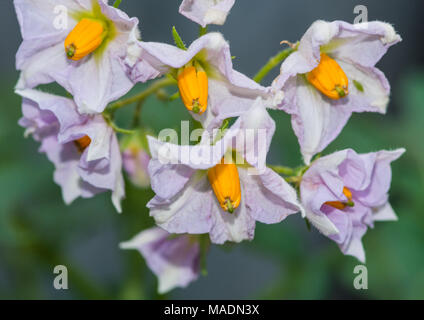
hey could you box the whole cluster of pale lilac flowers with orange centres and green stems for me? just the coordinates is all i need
[14,0,405,293]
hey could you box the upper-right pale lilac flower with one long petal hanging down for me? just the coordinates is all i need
[273,21,401,164]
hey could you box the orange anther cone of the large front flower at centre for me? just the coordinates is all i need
[208,159,241,213]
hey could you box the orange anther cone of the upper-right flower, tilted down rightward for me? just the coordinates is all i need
[306,53,349,100]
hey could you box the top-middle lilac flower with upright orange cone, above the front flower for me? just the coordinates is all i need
[132,33,269,128]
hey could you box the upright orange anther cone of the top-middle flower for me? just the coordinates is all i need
[178,66,208,114]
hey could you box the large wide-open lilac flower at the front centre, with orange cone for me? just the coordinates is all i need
[148,98,301,244]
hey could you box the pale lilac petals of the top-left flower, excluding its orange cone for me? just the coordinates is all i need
[15,0,142,113]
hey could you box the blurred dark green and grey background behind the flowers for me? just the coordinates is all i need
[0,0,424,299]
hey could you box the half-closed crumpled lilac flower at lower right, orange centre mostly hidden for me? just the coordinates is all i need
[300,149,405,262]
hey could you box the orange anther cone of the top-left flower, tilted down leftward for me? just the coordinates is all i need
[65,18,107,61]
